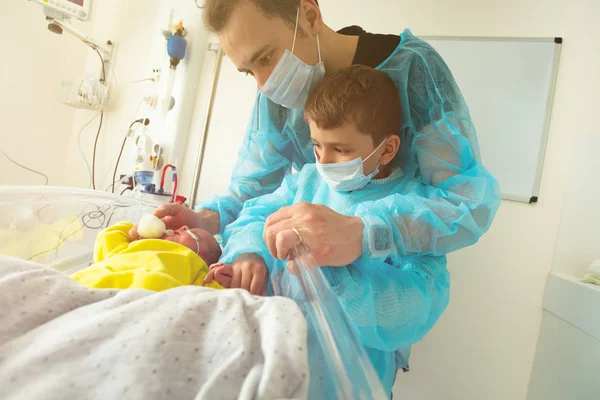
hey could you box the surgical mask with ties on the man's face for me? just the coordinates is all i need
[260,8,325,108]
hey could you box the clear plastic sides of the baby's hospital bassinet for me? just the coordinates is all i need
[0,186,386,399]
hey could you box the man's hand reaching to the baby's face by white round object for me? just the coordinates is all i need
[129,204,219,240]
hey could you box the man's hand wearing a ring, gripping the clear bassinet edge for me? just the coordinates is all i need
[263,203,364,267]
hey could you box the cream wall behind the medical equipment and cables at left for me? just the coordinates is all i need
[0,0,178,190]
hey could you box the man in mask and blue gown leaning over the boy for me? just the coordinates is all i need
[131,0,500,289]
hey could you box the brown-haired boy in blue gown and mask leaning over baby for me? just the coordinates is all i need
[208,66,449,393]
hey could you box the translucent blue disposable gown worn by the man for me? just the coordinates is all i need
[198,30,500,261]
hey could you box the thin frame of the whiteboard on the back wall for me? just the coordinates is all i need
[419,35,563,204]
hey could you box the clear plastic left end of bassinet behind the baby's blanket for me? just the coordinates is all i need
[0,186,156,273]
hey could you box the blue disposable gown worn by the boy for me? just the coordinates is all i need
[221,164,450,392]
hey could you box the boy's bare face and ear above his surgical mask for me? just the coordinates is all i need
[309,121,386,175]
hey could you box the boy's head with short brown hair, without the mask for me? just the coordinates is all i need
[304,65,402,178]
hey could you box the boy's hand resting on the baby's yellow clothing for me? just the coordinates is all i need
[230,254,268,296]
